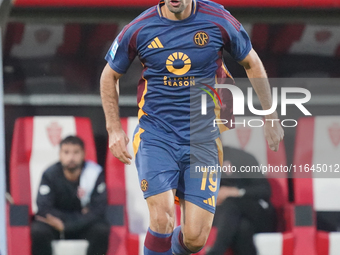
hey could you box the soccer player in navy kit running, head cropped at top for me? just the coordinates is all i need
[101,0,283,255]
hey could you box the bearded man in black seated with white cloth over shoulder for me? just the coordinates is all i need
[31,136,110,255]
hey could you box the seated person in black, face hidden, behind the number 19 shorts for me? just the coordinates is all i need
[207,147,276,255]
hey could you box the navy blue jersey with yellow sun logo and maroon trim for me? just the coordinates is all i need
[105,0,252,143]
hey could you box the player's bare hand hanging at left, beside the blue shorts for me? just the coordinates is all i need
[109,129,132,165]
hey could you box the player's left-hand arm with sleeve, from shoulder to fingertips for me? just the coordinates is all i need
[100,13,146,164]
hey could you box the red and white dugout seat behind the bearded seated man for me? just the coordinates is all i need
[7,116,97,255]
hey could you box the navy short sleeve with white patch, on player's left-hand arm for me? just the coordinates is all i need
[105,25,137,74]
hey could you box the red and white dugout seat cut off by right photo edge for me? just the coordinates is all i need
[294,116,340,255]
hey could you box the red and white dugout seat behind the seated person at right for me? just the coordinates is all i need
[206,117,294,255]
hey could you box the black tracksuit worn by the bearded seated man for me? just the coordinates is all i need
[31,163,110,255]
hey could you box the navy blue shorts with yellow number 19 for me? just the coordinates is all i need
[133,126,223,213]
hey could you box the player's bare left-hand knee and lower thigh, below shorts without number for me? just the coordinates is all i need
[146,189,176,234]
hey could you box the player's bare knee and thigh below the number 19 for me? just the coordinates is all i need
[180,200,214,251]
